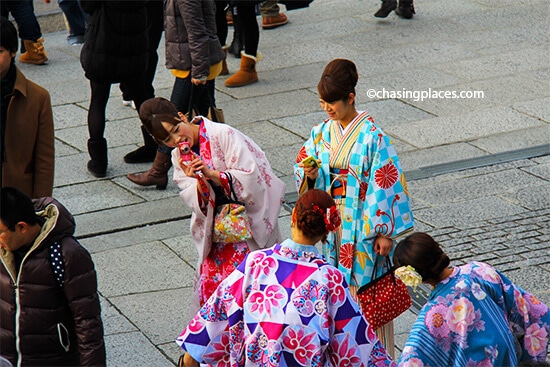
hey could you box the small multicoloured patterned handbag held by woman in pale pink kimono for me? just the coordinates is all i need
[212,172,252,243]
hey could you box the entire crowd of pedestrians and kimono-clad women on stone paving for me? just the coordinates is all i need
[0,0,550,366]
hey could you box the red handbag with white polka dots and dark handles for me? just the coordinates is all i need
[357,256,412,330]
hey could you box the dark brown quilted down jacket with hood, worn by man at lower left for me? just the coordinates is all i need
[0,197,106,366]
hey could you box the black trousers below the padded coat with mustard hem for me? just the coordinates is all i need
[158,75,216,154]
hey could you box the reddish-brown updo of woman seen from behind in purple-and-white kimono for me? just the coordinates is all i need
[294,189,336,242]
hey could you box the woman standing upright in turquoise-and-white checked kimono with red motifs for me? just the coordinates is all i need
[294,59,413,352]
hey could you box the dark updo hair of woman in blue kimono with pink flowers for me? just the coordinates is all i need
[393,232,451,282]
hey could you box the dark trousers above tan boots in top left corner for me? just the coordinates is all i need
[0,0,42,44]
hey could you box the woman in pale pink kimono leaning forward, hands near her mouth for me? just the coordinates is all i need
[140,98,285,311]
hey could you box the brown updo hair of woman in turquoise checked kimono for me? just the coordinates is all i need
[317,59,359,103]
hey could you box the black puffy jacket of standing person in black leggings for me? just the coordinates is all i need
[80,0,148,83]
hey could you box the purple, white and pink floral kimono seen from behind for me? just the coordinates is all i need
[176,240,395,367]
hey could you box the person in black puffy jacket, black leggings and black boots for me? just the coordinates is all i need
[80,0,153,177]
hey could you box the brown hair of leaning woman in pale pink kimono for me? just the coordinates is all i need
[139,97,182,145]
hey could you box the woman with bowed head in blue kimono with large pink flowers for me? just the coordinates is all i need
[393,232,550,367]
